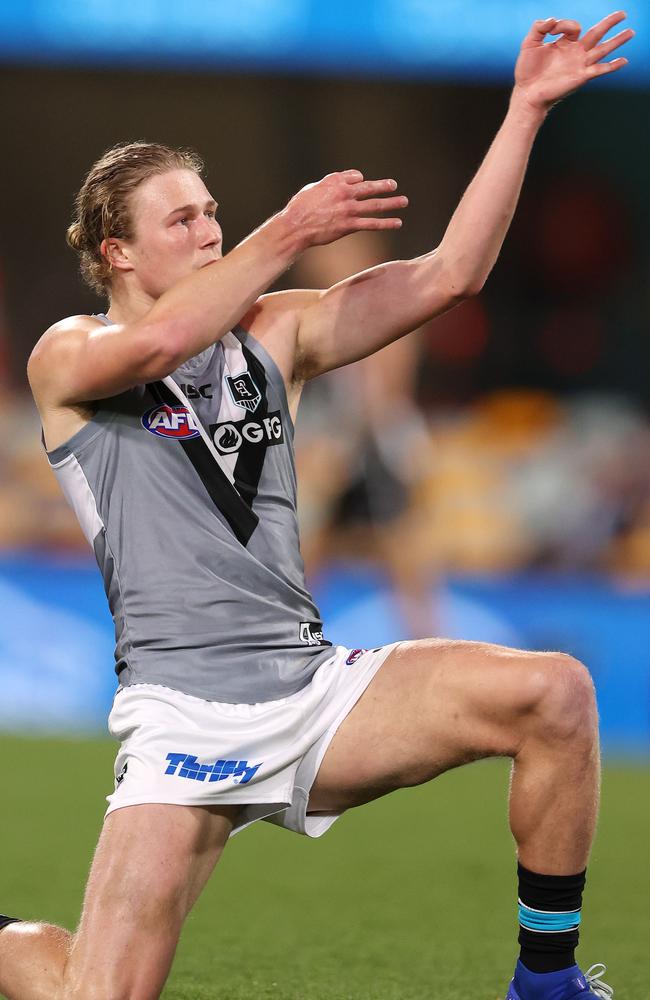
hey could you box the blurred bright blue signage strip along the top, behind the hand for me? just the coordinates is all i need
[0,0,650,86]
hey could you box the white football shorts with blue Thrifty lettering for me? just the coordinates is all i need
[106,643,396,837]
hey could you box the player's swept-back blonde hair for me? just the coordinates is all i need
[66,142,205,295]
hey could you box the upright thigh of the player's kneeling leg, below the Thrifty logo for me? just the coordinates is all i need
[63,804,238,1000]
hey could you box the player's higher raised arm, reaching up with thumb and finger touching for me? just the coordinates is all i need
[296,11,634,379]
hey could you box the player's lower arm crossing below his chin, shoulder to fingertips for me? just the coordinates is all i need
[28,170,403,406]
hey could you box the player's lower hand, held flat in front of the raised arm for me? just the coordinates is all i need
[280,170,408,250]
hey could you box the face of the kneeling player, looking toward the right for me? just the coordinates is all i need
[117,170,222,299]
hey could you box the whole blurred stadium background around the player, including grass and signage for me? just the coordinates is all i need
[0,0,650,1000]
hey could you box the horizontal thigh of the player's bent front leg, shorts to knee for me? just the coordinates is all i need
[309,639,561,812]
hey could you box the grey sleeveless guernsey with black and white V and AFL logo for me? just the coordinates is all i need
[48,315,331,704]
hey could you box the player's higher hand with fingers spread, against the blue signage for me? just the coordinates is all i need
[515,10,634,112]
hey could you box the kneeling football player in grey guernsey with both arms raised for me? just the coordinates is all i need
[0,13,632,1000]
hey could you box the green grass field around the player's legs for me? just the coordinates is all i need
[0,737,650,1000]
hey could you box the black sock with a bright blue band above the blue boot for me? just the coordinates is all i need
[517,865,586,972]
